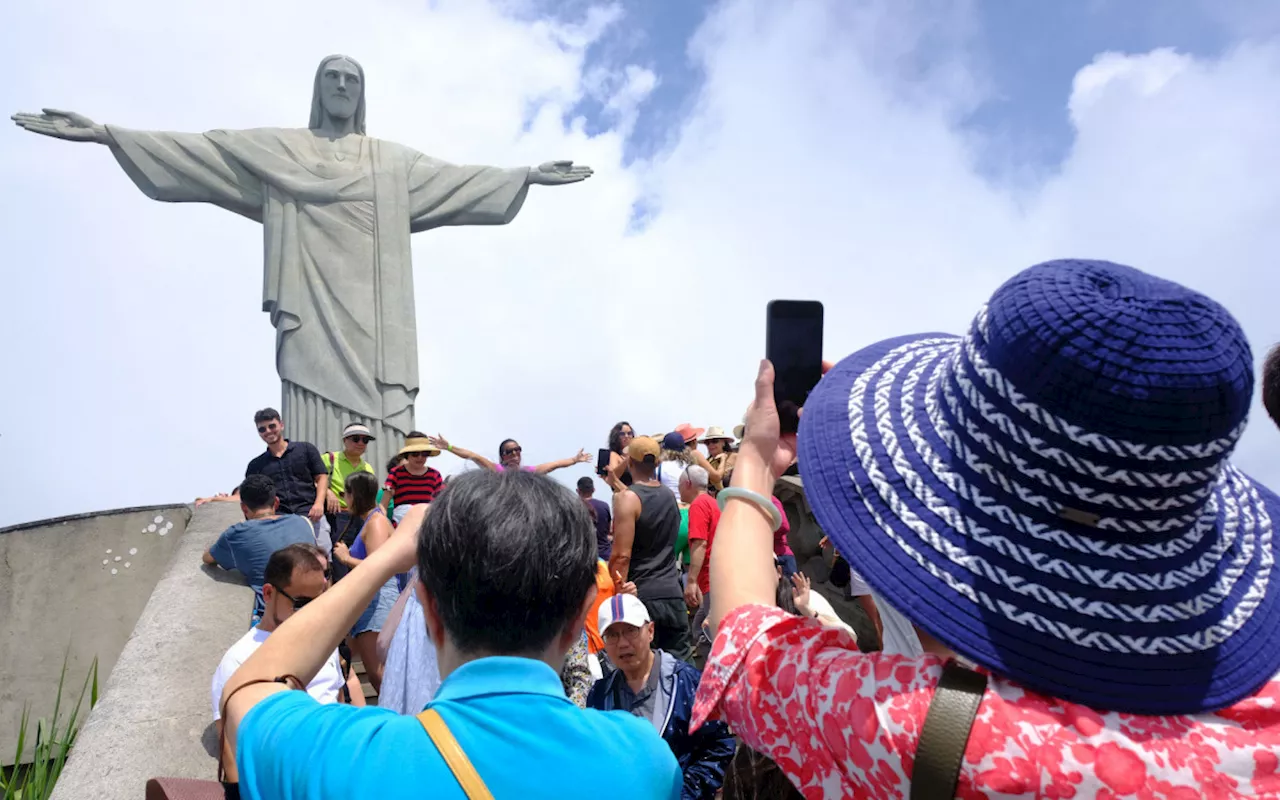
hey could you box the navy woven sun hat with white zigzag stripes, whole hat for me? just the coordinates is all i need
[800,261,1280,714]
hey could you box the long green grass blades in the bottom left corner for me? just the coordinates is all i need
[0,658,97,800]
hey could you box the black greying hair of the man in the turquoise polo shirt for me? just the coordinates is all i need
[417,470,598,655]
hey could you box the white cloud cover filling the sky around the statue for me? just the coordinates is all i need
[0,0,1280,524]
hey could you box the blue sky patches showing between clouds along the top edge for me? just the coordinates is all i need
[570,0,1280,171]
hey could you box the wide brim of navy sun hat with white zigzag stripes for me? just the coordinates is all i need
[799,334,1280,714]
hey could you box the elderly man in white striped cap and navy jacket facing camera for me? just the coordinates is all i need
[586,594,736,800]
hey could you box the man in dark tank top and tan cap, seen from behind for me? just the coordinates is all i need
[609,436,694,660]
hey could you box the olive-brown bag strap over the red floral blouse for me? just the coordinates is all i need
[910,660,987,800]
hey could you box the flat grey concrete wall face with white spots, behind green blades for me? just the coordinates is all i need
[0,506,191,765]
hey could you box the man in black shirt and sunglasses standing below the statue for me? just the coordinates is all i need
[244,408,329,526]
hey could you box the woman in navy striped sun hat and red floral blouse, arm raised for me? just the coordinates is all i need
[694,261,1280,797]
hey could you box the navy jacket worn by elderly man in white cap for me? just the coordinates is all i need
[586,650,737,800]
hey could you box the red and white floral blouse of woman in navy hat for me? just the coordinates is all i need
[691,605,1280,800]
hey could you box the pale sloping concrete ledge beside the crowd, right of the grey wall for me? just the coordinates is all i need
[54,503,253,800]
